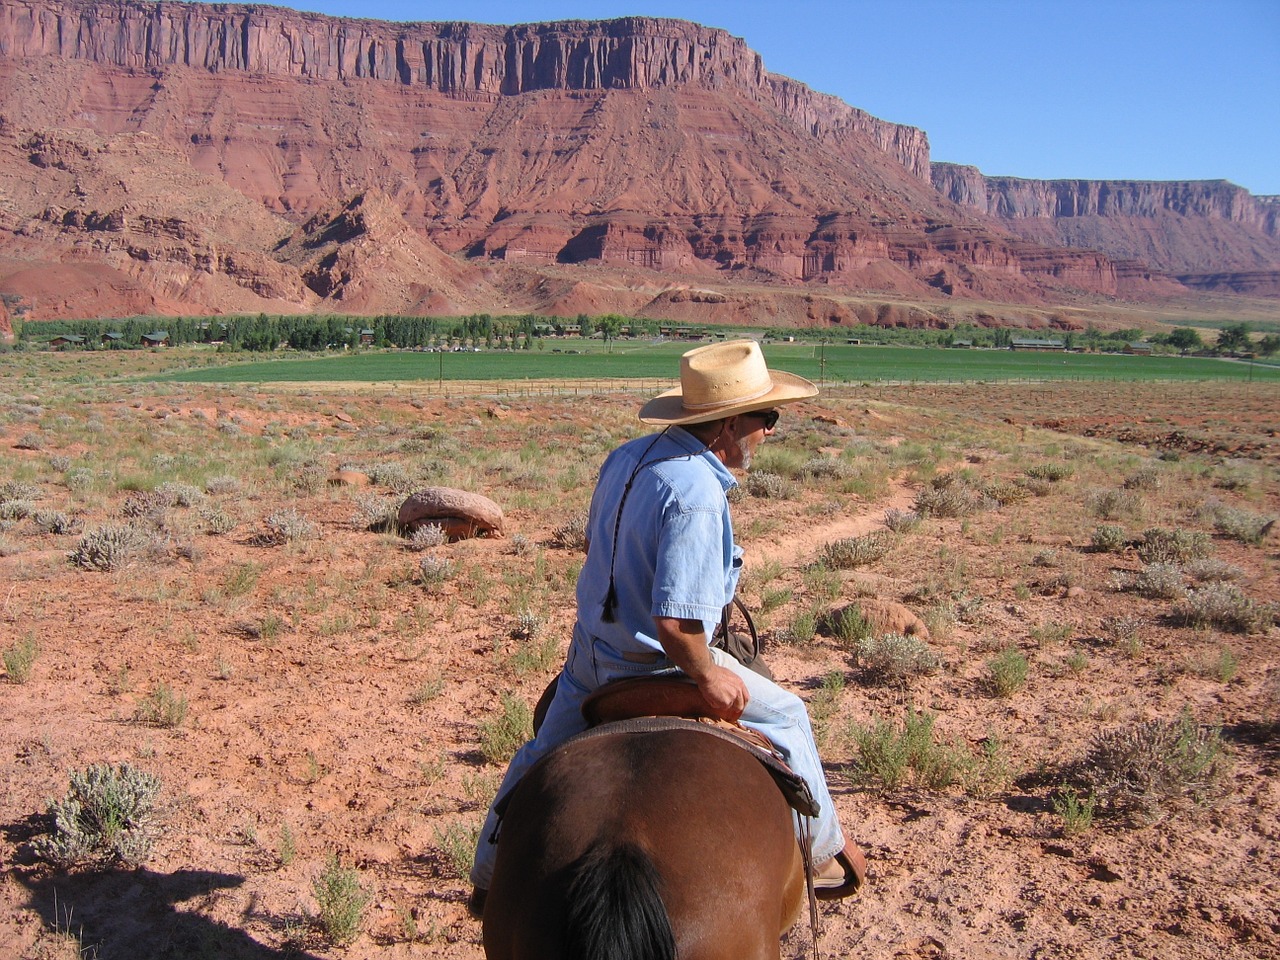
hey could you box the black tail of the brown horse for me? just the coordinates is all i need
[564,844,676,960]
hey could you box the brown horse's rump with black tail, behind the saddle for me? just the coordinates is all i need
[484,730,805,960]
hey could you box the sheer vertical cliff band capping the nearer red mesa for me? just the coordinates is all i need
[0,0,929,182]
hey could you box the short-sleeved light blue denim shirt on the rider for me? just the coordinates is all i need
[576,426,742,653]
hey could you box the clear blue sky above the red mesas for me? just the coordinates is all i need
[275,0,1280,195]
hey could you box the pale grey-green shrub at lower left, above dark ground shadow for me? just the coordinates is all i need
[32,763,160,867]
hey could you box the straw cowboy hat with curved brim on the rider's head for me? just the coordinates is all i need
[640,340,818,424]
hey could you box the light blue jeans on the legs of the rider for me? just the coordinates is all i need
[471,630,845,890]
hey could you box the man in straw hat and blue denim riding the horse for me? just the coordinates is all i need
[468,340,865,916]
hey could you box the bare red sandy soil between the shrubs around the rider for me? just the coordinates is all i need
[0,385,1280,960]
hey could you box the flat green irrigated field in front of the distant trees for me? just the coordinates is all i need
[148,340,1280,383]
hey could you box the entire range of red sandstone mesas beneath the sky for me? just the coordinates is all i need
[0,0,1280,325]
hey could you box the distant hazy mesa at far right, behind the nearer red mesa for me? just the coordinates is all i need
[932,163,1280,284]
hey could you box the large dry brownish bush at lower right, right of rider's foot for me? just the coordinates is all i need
[1079,712,1228,823]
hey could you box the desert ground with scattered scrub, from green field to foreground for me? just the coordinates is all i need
[0,355,1280,960]
